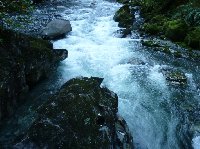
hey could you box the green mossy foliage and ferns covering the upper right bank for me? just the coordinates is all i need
[129,0,200,51]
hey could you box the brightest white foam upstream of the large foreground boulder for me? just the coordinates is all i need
[54,1,130,79]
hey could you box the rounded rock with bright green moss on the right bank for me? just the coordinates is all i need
[164,19,188,41]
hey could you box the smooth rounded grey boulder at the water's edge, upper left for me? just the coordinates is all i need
[41,19,72,39]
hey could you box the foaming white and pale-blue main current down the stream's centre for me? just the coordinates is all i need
[54,0,200,149]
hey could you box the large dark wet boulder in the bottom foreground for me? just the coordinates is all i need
[14,77,133,149]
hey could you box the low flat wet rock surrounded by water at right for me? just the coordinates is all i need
[161,68,187,85]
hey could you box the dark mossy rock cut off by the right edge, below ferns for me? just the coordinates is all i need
[185,27,200,49]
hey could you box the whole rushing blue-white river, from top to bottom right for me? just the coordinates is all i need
[0,0,200,149]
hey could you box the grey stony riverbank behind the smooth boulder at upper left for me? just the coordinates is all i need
[0,0,75,37]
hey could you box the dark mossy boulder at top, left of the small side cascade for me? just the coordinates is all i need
[113,4,134,28]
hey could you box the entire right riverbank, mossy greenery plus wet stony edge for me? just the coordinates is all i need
[114,0,200,61]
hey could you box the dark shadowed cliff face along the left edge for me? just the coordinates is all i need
[0,29,67,120]
